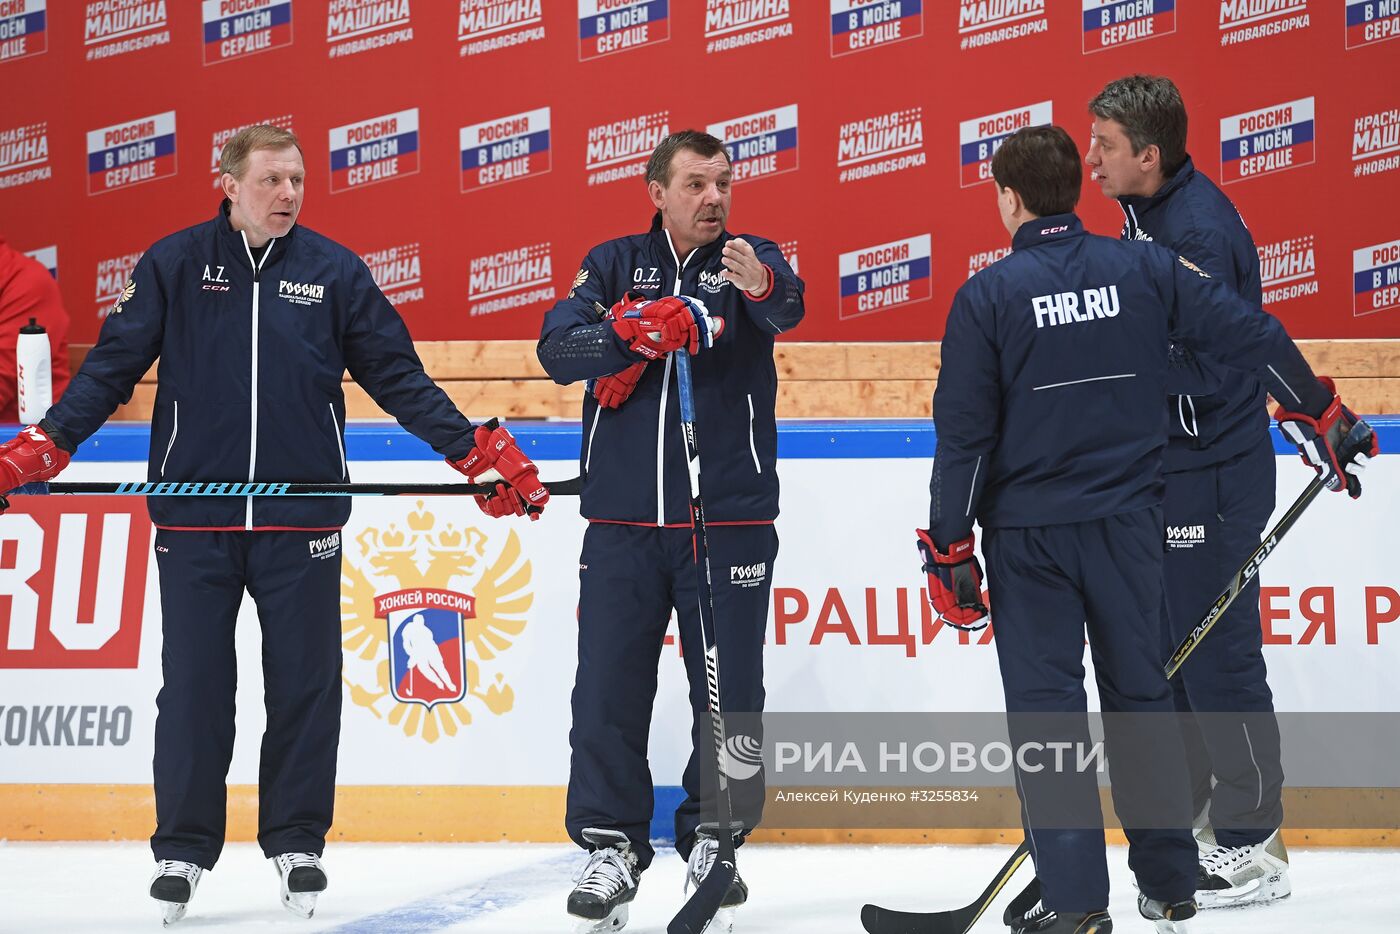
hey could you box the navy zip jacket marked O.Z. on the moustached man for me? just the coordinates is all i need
[539,218,804,527]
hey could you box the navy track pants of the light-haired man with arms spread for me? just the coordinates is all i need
[151,529,340,870]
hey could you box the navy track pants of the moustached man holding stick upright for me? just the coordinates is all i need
[564,522,778,868]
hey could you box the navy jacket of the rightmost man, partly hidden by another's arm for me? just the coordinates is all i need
[1119,158,1282,472]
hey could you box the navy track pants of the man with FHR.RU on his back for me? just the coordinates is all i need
[984,508,1196,912]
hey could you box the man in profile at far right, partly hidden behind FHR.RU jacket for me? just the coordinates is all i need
[1085,74,1365,907]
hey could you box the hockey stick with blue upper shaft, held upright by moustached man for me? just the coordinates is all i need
[666,350,736,934]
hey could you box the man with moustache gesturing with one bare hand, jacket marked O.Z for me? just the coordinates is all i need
[539,130,804,927]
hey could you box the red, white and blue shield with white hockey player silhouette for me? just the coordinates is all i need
[389,609,476,709]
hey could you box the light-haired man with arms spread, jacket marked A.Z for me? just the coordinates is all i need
[0,126,547,923]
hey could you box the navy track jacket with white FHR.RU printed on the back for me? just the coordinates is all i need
[930,214,1331,548]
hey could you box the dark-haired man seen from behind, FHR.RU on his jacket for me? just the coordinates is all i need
[918,126,1359,934]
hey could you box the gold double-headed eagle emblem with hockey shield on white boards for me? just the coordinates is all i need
[340,501,535,742]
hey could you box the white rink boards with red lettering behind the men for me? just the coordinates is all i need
[0,434,1400,786]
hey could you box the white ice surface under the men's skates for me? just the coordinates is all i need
[0,843,1400,934]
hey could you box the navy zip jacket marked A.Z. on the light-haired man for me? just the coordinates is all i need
[48,202,475,531]
